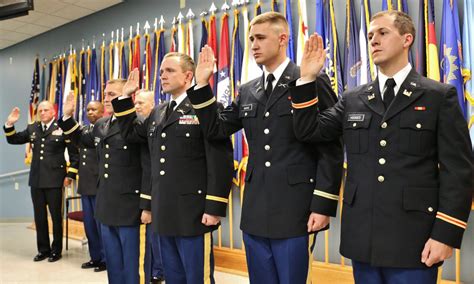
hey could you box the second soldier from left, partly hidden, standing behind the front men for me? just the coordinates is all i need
[66,101,105,272]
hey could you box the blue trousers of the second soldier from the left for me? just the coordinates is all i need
[81,195,105,262]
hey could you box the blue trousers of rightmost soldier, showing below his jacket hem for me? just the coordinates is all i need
[352,260,438,284]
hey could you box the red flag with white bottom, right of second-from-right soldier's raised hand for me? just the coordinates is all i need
[217,13,232,107]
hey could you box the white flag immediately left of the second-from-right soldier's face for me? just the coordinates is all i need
[241,6,263,84]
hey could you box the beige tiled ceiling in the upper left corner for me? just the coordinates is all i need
[0,0,122,50]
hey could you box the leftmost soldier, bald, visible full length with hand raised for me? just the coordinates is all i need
[4,101,79,262]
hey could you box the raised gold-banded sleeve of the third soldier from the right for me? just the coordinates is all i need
[112,98,148,143]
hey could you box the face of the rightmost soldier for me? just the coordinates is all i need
[367,15,407,66]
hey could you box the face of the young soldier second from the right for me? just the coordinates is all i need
[249,22,282,66]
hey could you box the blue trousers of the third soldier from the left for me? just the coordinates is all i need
[101,224,140,284]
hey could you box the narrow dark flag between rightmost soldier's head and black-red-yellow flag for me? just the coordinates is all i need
[413,0,426,76]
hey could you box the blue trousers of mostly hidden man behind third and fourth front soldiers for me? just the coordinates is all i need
[144,224,164,283]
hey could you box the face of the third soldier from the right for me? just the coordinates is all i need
[160,57,190,95]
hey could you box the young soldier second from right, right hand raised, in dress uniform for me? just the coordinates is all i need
[188,12,343,283]
